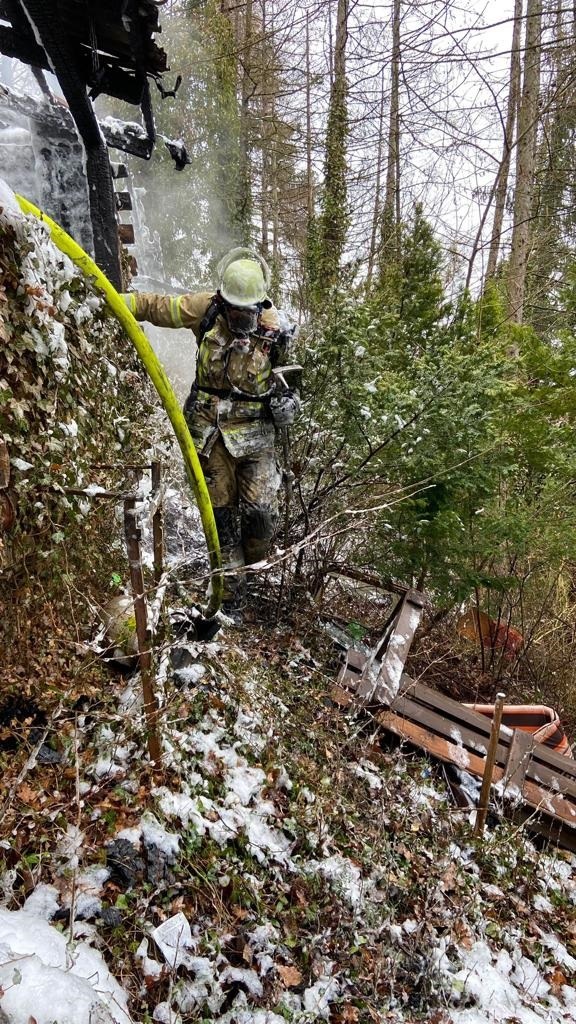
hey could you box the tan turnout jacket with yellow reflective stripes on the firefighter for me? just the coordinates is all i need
[125,292,285,457]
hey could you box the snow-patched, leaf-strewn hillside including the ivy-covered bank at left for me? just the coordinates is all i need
[0,182,576,1024]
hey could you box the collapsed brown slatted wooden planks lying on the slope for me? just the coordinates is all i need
[332,592,576,852]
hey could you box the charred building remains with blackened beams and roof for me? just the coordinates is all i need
[0,0,187,287]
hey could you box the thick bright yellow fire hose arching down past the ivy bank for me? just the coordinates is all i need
[16,196,223,618]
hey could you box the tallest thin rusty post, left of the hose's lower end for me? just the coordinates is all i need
[124,498,162,768]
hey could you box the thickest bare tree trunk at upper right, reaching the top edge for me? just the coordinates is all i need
[508,0,542,324]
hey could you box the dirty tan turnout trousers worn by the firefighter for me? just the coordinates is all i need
[200,437,282,600]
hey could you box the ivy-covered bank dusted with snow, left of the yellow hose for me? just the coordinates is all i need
[0,182,153,584]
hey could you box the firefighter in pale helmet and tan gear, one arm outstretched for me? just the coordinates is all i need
[125,248,299,617]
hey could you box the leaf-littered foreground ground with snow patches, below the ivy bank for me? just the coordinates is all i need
[0,491,576,1024]
